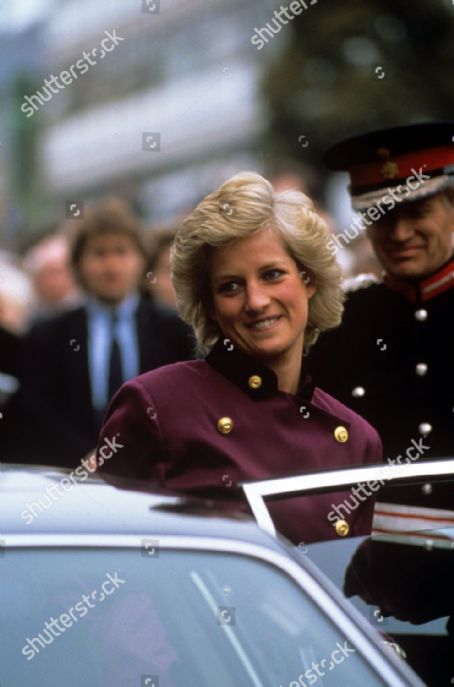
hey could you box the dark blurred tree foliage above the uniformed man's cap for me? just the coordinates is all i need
[263,0,454,164]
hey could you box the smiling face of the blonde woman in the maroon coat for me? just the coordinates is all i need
[209,229,315,377]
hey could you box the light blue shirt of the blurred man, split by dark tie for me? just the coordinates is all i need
[87,294,139,412]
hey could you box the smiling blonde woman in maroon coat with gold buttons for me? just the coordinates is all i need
[97,172,382,542]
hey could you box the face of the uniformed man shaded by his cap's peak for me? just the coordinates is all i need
[367,193,454,279]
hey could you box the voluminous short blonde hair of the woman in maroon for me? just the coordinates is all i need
[171,172,344,354]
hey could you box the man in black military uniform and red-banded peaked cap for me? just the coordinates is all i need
[307,123,454,505]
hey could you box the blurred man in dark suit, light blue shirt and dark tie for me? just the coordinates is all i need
[21,199,192,467]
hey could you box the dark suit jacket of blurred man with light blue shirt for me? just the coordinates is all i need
[15,298,194,467]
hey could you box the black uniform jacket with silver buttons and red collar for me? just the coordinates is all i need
[307,260,454,504]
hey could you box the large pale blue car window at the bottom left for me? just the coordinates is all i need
[0,542,384,687]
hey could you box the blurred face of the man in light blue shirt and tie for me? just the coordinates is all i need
[79,234,144,304]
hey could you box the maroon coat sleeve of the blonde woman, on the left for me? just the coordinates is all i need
[96,379,165,484]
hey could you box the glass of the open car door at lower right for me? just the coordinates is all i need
[306,528,454,687]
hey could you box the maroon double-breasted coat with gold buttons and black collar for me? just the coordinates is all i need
[98,339,382,542]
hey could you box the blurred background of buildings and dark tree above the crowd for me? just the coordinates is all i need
[0,0,454,332]
